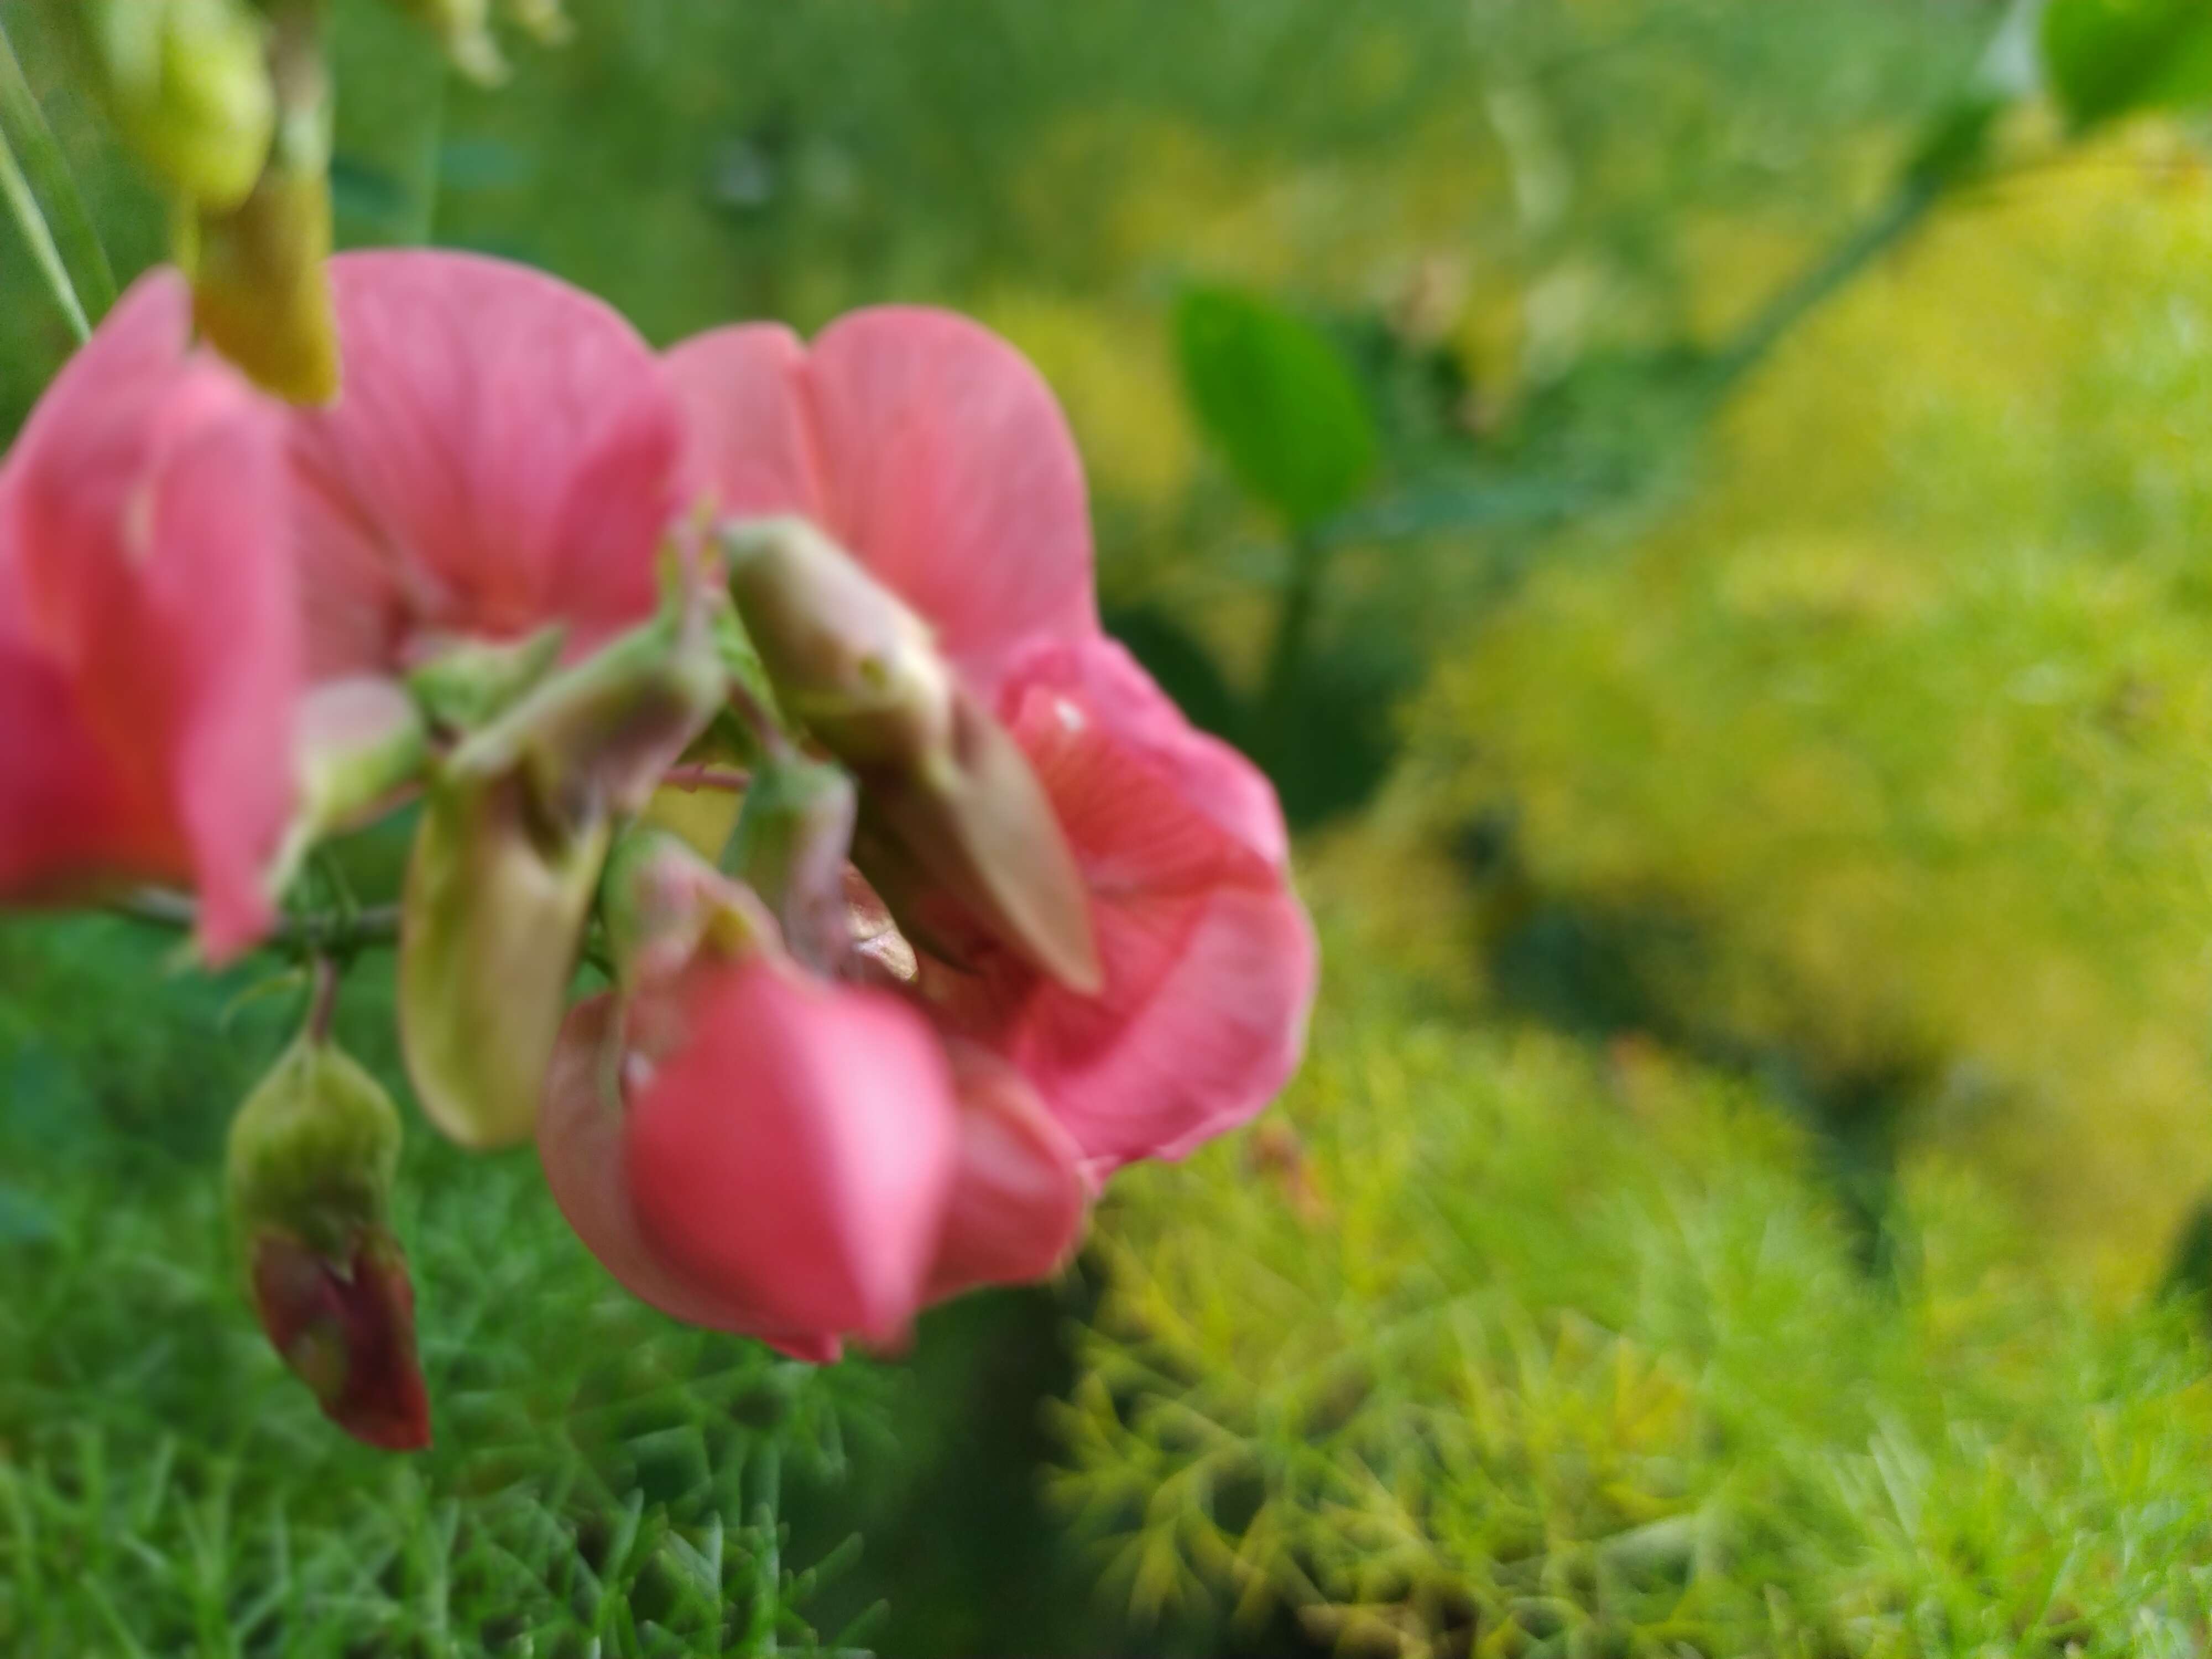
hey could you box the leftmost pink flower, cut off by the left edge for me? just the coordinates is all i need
[0,272,301,958]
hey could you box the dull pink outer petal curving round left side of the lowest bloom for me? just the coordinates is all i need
[538,995,841,1365]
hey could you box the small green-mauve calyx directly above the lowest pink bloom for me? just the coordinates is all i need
[730,757,856,973]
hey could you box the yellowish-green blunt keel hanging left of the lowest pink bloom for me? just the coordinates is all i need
[398,772,608,1148]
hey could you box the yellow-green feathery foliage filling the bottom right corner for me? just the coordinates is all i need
[1057,896,2212,1659]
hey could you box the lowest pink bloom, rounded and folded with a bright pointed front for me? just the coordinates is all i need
[538,951,956,1360]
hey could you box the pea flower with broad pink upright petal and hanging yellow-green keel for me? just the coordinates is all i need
[276,252,719,1146]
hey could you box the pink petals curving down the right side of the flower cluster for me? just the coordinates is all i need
[668,310,1316,1172]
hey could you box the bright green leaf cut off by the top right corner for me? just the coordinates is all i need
[2042,0,2212,131]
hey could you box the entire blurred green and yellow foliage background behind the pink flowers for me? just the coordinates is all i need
[22,0,2212,1659]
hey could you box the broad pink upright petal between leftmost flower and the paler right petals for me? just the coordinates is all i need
[292,252,684,677]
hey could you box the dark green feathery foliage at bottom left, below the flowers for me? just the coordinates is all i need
[0,920,896,1659]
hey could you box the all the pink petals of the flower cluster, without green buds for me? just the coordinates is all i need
[0,252,1316,1358]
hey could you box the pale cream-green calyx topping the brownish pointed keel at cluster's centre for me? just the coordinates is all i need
[723,518,953,768]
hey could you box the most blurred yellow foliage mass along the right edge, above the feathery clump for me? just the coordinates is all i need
[1405,146,2212,1287]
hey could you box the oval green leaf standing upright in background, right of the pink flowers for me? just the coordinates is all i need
[1175,288,1376,529]
